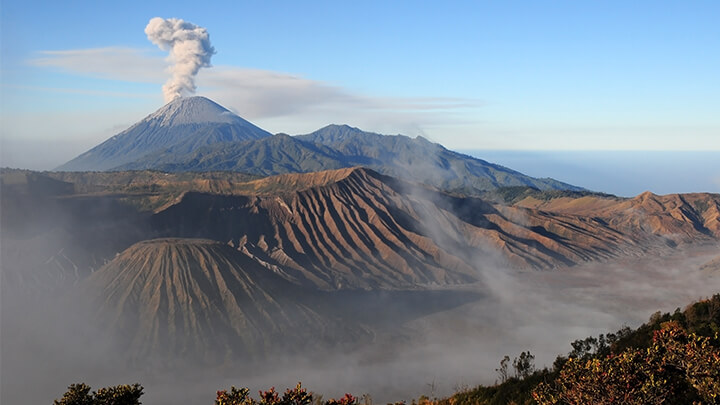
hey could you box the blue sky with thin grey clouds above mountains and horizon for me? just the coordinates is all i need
[0,0,720,168]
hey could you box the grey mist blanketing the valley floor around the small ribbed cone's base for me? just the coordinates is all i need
[2,238,720,404]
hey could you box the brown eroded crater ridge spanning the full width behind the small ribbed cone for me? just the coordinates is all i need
[2,164,720,289]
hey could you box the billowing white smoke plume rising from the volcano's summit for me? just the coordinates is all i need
[145,17,215,102]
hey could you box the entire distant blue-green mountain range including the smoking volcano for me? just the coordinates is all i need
[58,97,582,195]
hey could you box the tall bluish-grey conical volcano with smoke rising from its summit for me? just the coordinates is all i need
[57,96,270,171]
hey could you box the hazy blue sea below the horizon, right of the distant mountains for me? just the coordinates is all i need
[459,150,720,197]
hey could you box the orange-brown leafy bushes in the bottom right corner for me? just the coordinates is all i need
[533,322,720,404]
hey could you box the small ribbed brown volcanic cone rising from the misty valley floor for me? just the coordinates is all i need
[82,238,354,363]
